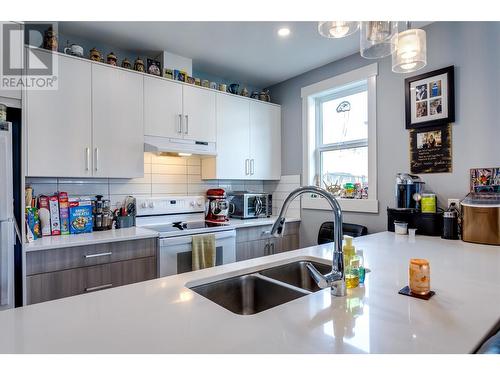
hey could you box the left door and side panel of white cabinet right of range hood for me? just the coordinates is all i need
[202,94,250,179]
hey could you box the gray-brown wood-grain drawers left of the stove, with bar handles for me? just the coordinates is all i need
[26,238,157,304]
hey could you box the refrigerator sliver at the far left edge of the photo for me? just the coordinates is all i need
[0,122,15,311]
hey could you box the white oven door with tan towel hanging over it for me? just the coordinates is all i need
[158,229,236,277]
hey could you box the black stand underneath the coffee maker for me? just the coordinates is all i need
[387,208,443,236]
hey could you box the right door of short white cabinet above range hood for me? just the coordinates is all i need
[183,86,216,142]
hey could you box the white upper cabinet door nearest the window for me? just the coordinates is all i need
[250,101,281,180]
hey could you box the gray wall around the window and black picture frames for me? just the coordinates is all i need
[270,22,500,245]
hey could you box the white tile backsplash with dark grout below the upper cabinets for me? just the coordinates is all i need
[26,152,266,212]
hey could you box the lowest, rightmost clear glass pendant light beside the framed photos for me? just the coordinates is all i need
[392,22,427,73]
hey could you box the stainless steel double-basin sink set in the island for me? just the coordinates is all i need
[190,260,331,315]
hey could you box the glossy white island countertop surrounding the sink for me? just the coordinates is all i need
[4,232,500,353]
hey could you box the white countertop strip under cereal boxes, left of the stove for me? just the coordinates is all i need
[24,227,158,252]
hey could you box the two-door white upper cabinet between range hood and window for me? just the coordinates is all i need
[202,94,281,180]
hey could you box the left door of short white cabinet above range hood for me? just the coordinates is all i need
[144,77,184,138]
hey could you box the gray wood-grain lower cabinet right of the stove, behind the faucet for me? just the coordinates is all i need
[236,222,300,261]
